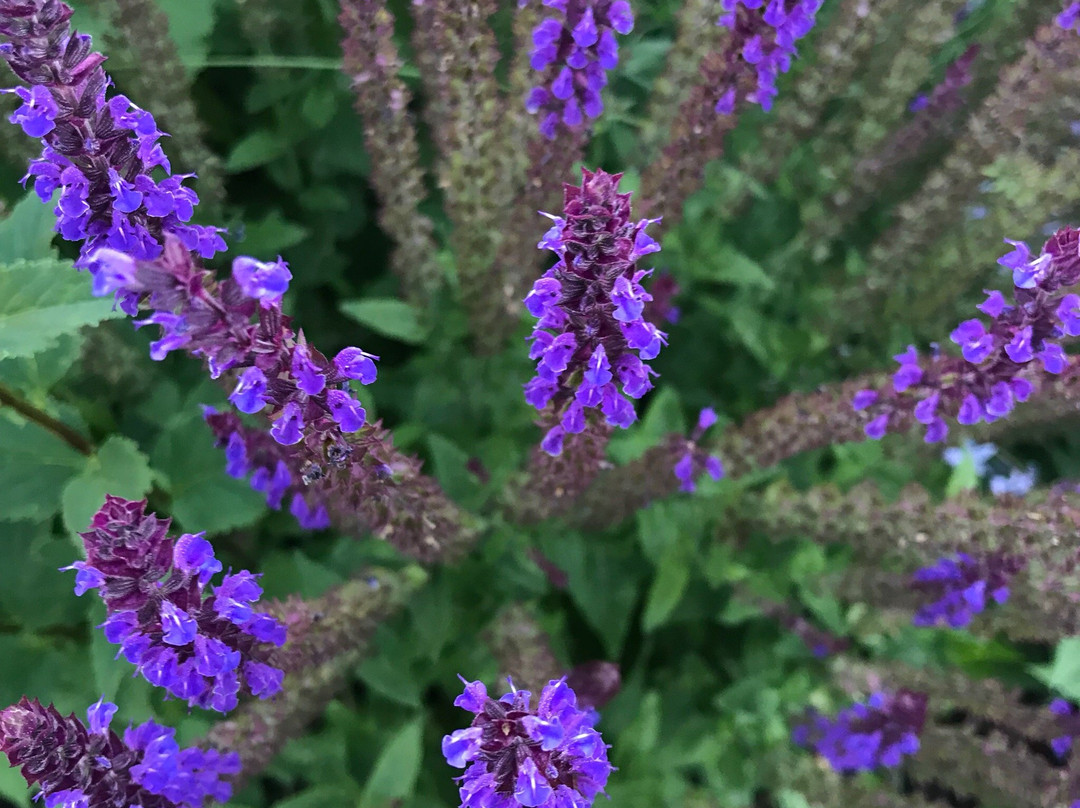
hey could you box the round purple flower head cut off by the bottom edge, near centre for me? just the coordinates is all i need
[443,677,611,808]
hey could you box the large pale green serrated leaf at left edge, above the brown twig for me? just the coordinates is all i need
[0,258,123,359]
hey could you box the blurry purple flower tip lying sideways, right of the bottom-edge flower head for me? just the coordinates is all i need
[792,690,927,773]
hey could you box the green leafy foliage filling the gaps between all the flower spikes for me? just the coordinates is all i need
[0,0,1080,808]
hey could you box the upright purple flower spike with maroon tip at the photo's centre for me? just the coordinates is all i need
[525,169,666,456]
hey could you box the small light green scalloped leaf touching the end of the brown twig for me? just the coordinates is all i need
[60,435,151,534]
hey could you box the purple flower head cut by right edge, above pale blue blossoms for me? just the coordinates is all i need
[852,227,1080,443]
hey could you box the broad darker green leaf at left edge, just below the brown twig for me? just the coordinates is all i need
[0,418,86,522]
